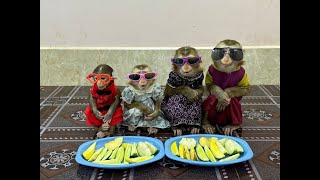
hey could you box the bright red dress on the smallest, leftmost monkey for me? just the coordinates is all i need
[84,82,123,126]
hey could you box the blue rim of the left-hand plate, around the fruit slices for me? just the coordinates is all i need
[76,136,164,169]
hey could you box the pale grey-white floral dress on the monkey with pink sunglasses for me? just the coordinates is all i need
[121,83,170,129]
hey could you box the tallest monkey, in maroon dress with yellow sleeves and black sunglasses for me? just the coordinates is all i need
[202,39,251,136]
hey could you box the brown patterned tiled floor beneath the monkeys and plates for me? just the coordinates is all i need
[40,85,280,180]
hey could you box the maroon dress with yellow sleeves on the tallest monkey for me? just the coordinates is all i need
[203,65,250,126]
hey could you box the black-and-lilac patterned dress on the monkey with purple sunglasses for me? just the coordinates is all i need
[161,71,204,126]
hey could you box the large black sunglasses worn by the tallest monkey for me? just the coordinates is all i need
[211,48,243,61]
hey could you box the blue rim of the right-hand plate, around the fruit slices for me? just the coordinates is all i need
[164,134,253,166]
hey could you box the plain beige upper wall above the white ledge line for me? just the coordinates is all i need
[40,0,280,47]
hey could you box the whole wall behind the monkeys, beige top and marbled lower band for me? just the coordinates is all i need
[40,0,280,85]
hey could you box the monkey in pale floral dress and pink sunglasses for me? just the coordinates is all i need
[121,64,170,135]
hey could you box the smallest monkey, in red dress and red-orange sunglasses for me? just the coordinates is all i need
[84,64,123,139]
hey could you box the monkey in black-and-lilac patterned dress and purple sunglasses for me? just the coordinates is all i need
[161,46,204,136]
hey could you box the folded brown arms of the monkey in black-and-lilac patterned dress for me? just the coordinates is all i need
[164,84,202,101]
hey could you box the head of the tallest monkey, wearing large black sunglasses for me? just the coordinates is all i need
[211,43,243,73]
